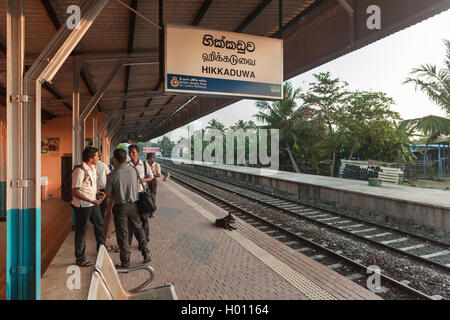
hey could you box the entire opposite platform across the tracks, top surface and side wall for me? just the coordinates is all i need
[158,158,450,239]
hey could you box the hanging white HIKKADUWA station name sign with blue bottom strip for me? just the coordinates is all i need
[164,25,283,99]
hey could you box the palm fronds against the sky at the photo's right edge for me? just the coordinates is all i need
[404,40,450,114]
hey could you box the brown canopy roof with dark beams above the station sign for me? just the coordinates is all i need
[0,0,450,141]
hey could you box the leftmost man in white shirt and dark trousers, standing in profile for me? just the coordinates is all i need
[71,147,106,267]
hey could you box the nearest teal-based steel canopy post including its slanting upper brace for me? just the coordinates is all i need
[6,0,109,300]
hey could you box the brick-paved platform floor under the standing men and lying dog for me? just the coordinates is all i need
[42,181,380,300]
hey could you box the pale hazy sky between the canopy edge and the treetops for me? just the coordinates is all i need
[158,10,450,140]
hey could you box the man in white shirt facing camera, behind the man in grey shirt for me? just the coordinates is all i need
[128,144,154,245]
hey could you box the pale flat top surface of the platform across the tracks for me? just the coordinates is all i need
[163,158,450,209]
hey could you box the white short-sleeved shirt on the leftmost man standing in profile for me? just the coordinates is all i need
[72,162,97,208]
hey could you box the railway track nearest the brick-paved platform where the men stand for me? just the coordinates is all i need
[162,165,444,299]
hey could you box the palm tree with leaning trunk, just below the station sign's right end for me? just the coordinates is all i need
[255,81,301,172]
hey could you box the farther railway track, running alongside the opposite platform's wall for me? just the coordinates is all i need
[162,165,450,273]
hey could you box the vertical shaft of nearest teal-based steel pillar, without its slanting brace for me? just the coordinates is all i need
[6,0,41,300]
